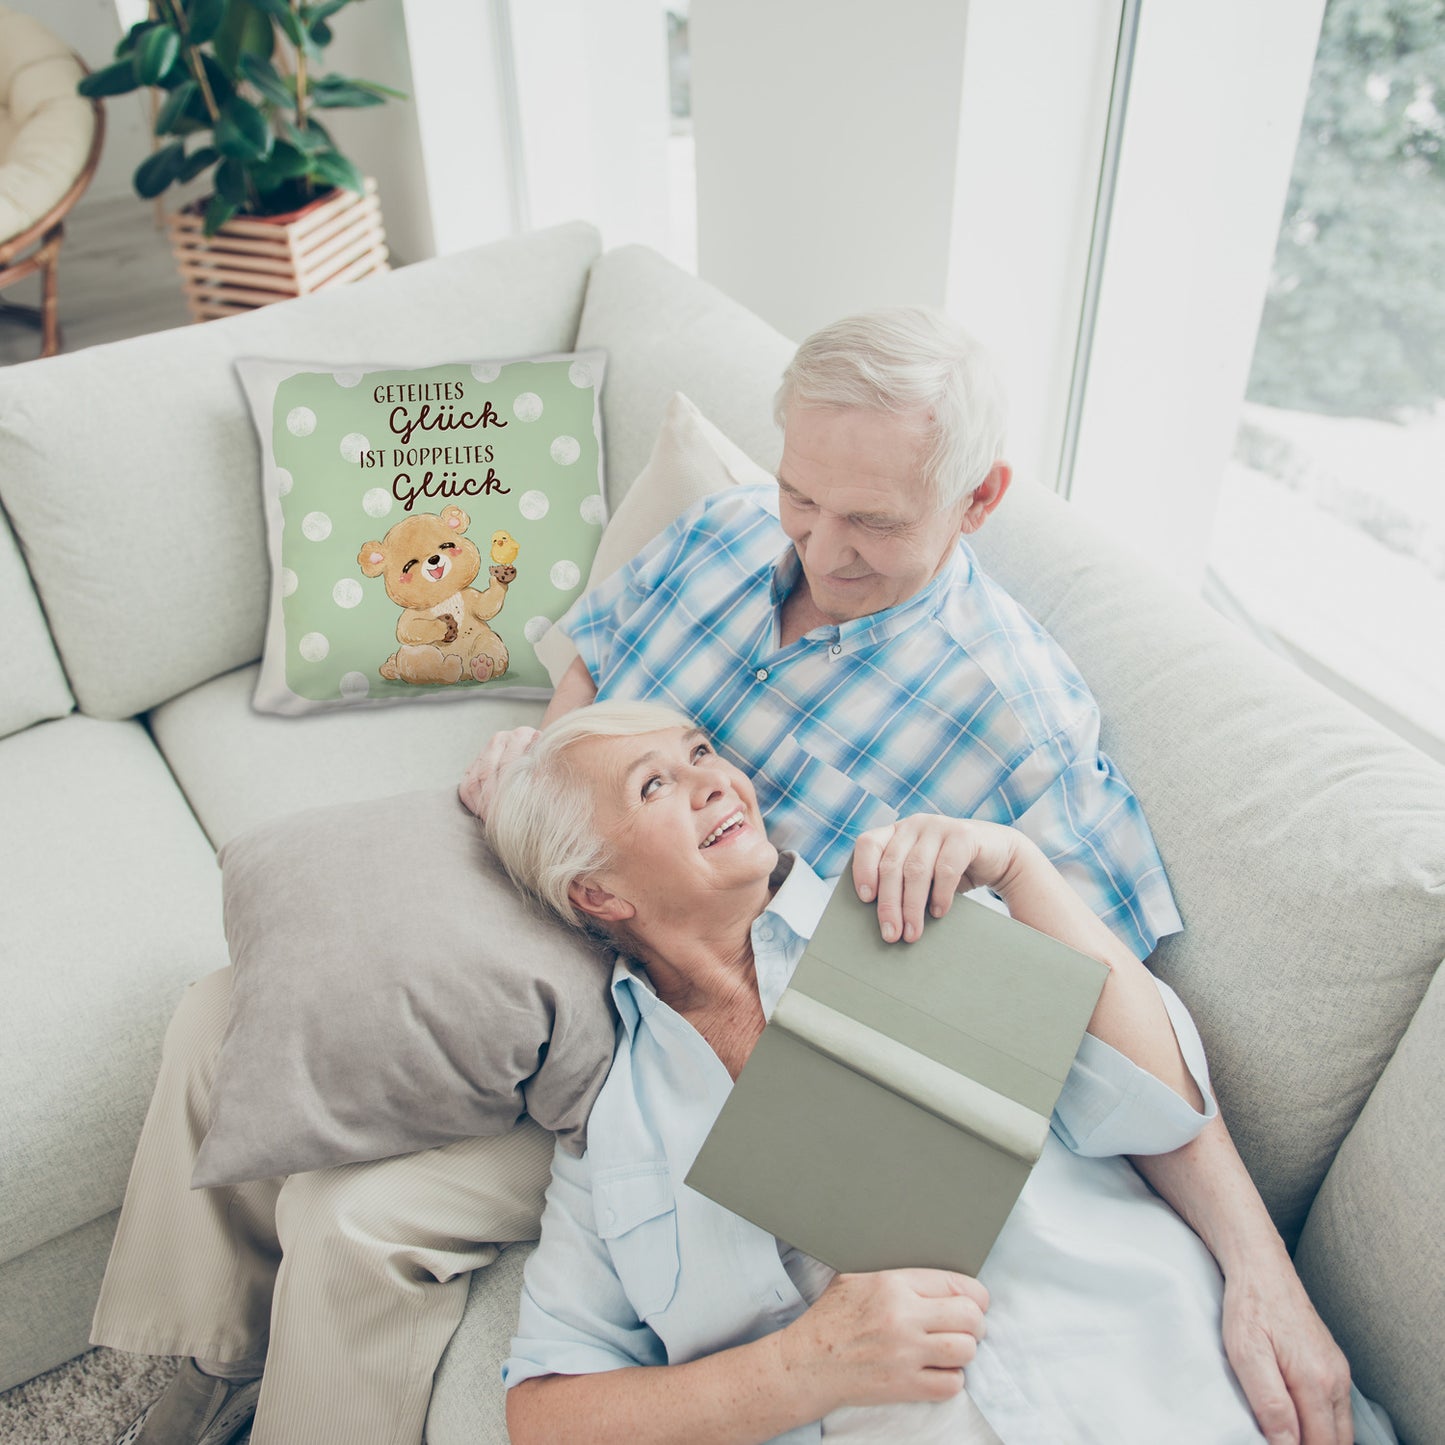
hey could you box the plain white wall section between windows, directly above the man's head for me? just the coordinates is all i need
[691,0,968,337]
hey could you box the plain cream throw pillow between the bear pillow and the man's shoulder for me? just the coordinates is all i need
[536,392,776,686]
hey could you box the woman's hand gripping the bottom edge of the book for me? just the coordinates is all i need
[779,1269,988,1413]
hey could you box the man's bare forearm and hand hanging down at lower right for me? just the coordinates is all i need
[1131,1116,1354,1445]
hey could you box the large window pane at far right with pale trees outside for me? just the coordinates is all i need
[1209,0,1445,753]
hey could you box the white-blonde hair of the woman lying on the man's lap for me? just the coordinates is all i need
[487,702,694,944]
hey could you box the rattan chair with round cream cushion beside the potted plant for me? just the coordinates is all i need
[0,6,105,357]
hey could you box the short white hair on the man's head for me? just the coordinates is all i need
[773,306,1006,507]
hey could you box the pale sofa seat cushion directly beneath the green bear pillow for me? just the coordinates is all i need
[149,666,542,848]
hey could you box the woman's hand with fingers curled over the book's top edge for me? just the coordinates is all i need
[853,814,1036,944]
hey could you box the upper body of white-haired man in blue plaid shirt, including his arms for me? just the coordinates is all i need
[462,309,1351,1445]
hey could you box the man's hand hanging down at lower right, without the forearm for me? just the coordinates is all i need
[1224,1260,1354,1445]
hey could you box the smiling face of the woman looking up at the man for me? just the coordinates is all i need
[569,727,777,925]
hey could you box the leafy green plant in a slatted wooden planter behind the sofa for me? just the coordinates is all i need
[79,0,405,319]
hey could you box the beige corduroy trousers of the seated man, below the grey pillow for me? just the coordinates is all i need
[91,968,552,1445]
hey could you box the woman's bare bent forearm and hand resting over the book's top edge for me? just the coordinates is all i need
[853,814,1204,1111]
